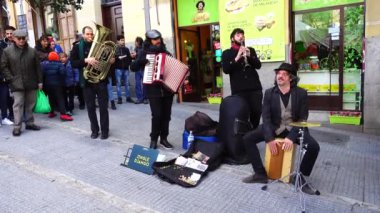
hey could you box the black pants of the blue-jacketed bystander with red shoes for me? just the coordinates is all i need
[46,85,65,115]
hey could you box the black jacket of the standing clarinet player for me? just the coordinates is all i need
[222,48,262,95]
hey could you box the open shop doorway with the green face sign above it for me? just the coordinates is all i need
[174,0,222,102]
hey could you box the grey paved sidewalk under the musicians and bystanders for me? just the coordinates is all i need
[0,103,380,212]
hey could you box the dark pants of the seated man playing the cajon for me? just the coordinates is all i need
[243,125,319,176]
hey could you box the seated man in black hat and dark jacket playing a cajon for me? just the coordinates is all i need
[243,63,319,194]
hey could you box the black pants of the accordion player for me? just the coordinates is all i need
[149,96,173,141]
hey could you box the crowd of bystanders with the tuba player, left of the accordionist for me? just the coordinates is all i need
[0,26,148,139]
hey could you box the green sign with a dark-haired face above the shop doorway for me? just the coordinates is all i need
[177,0,219,27]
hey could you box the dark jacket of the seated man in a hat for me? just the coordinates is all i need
[262,86,309,142]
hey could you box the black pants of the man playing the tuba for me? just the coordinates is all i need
[83,82,109,134]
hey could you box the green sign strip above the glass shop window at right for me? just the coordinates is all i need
[293,0,364,11]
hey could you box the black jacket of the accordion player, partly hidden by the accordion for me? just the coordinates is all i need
[131,45,173,98]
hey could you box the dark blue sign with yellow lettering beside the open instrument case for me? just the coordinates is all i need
[127,144,158,175]
